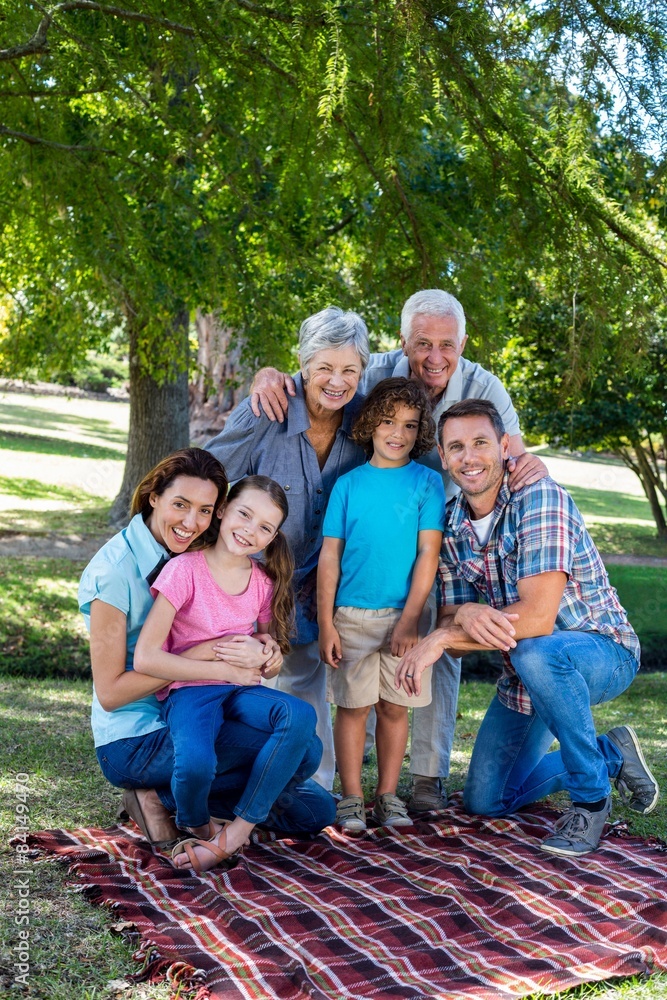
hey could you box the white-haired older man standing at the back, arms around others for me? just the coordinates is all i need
[252,288,547,812]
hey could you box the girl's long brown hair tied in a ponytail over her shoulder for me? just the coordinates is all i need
[227,476,294,653]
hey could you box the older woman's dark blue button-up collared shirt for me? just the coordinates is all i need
[206,373,366,643]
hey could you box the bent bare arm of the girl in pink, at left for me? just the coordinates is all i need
[134,594,261,687]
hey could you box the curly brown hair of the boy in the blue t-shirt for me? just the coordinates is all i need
[352,378,435,458]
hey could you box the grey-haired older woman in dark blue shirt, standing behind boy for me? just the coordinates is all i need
[206,306,370,789]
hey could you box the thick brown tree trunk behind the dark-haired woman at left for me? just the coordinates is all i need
[109,312,190,527]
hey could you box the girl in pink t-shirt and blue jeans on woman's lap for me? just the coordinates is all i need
[135,476,319,871]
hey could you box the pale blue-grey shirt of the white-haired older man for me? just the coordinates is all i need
[360,348,521,500]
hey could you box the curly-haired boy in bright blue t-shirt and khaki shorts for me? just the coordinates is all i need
[317,378,445,832]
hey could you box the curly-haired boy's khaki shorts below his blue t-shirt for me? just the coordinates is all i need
[327,608,431,708]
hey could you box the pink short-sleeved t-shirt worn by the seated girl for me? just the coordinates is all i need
[151,551,273,699]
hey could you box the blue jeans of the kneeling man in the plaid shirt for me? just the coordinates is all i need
[463,630,639,816]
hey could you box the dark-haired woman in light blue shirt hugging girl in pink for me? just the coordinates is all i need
[79,448,335,844]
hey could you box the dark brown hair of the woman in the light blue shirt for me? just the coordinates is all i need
[130,448,229,549]
